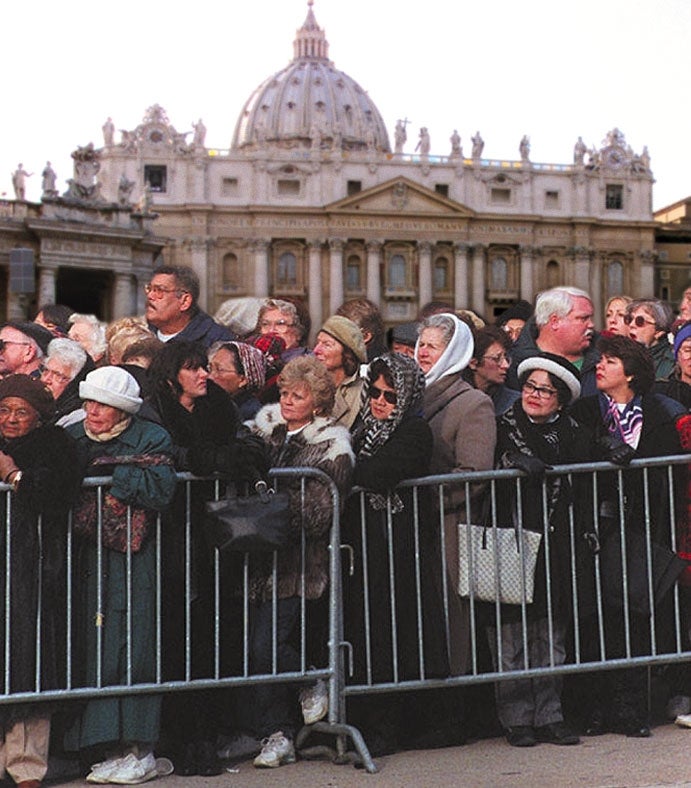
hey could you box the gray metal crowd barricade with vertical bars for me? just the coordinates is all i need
[0,455,691,771]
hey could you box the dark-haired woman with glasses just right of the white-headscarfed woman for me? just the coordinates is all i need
[463,326,520,416]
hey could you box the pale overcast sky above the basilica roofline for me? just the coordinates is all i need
[0,0,691,208]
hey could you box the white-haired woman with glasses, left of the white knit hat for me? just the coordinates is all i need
[41,338,94,427]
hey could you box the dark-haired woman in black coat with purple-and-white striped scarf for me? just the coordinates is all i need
[572,338,681,737]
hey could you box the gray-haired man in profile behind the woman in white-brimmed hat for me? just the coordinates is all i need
[506,287,598,397]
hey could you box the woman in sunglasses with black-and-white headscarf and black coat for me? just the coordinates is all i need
[342,353,449,754]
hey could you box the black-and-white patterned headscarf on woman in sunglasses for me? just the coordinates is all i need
[357,353,425,514]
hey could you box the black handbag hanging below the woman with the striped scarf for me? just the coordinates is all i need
[600,528,687,616]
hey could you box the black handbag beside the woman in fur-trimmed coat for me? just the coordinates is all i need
[205,481,290,553]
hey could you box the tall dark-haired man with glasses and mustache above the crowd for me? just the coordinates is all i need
[144,265,236,348]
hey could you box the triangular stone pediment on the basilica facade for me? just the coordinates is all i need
[326,178,475,218]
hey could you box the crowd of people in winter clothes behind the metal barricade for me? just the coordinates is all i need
[0,266,691,788]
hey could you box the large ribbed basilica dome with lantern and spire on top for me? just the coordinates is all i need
[231,0,391,153]
